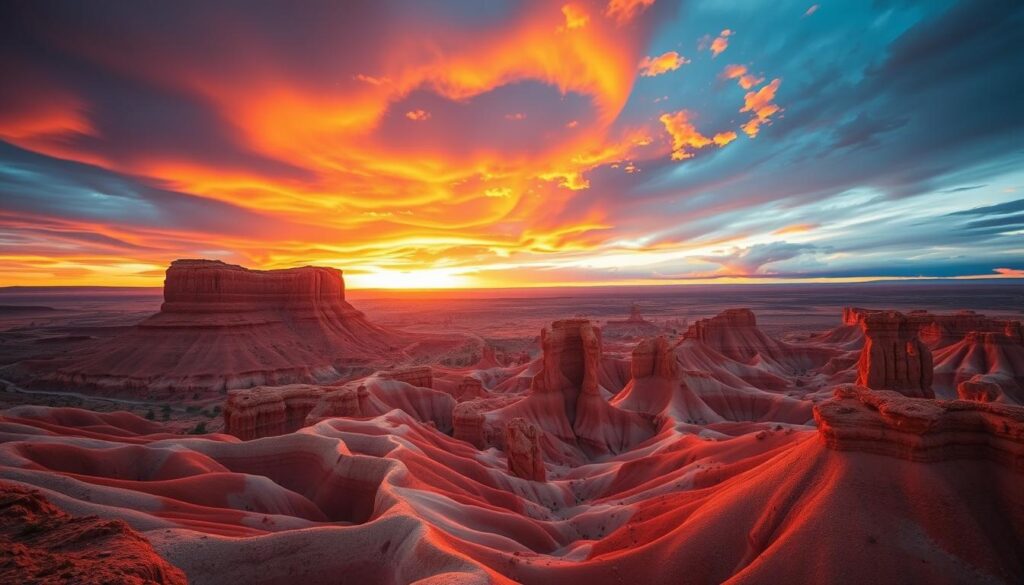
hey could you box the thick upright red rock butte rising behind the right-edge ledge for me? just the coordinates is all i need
[857,310,935,399]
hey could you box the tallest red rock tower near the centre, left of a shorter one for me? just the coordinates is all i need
[531,319,601,424]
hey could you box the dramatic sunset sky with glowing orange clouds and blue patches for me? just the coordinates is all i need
[0,0,1024,288]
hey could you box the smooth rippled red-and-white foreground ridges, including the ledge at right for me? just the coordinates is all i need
[0,390,1024,585]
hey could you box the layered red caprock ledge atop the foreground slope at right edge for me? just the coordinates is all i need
[814,384,1024,473]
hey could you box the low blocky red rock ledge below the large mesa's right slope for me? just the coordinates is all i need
[224,384,324,441]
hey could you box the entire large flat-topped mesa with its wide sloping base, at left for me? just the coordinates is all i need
[25,260,401,393]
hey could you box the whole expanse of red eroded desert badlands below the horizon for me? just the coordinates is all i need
[0,260,1024,585]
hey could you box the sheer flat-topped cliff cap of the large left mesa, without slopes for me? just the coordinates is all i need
[161,260,353,312]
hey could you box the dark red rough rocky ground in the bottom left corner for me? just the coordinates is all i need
[0,482,187,585]
